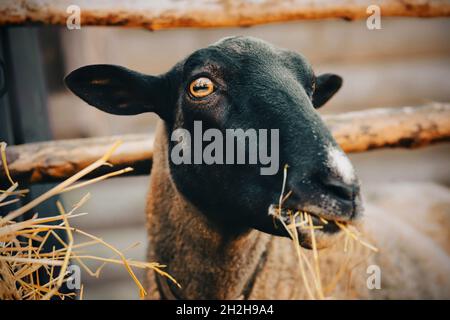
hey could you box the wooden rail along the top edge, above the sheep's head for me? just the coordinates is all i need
[0,0,450,30]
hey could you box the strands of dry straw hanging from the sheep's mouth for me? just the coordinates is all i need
[274,165,378,300]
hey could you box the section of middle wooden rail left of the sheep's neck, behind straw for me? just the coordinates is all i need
[0,135,153,183]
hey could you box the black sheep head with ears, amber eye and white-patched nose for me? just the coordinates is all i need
[66,37,361,246]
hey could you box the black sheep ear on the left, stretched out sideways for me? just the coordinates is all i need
[64,64,166,115]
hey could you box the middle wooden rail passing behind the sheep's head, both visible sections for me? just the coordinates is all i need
[0,103,450,183]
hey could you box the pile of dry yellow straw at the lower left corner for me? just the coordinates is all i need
[0,141,179,300]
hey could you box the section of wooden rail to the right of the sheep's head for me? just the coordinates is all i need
[323,103,450,152]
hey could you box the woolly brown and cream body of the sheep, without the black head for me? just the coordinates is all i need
[147,124,450,299]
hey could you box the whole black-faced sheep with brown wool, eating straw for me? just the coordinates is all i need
[65,37,450,299]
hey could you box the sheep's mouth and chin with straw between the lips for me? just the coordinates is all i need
[269,205,353,249]
